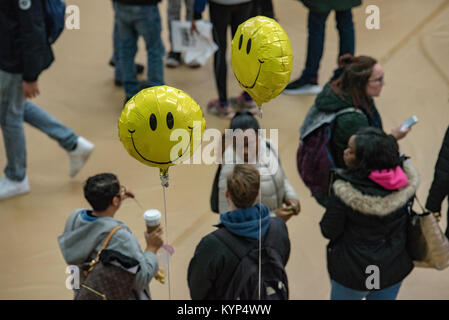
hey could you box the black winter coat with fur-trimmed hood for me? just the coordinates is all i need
[320,162,419,291]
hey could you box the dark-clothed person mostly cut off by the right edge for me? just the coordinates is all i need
[426,127,449,238]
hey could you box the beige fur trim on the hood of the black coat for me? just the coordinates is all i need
[333,160,419,217]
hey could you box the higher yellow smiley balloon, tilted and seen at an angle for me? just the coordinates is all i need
[231,16,293,106]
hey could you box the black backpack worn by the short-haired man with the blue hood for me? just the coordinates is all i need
[214,218,288,300]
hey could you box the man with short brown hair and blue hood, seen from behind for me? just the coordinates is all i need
[187,164,290,300]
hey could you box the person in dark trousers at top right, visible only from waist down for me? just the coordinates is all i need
[284,0,362,94]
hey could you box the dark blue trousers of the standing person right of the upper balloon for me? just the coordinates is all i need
[301,10,355,81]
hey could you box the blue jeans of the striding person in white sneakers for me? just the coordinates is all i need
[0,70,78,181]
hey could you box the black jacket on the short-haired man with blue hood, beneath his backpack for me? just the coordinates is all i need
[187,218,290,300]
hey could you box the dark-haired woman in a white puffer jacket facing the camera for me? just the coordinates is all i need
[218,112,301,221]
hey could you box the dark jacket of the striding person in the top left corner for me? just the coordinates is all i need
[0,0,54,82]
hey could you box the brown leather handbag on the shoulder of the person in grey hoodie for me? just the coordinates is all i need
[74,226,138,300]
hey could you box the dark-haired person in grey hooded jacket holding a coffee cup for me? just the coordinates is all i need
[58,173,163,300]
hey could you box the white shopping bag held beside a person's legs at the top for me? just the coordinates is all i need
[172,20,218,65]
